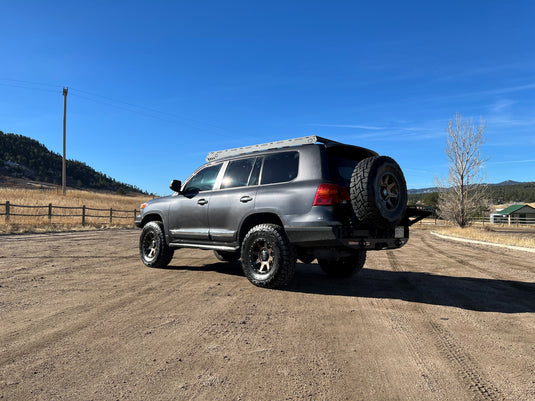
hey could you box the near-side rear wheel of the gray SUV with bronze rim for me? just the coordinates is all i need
[241,224,296,288]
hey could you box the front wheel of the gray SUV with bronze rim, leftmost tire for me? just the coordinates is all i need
[139,221,174,268]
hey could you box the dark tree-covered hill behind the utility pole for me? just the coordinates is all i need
[0,131,145,194]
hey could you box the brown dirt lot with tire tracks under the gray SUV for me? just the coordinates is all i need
[0,230,535,401]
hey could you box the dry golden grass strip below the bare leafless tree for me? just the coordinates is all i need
[433,225,535,248]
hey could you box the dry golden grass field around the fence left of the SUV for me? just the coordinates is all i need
[0,188,150,233]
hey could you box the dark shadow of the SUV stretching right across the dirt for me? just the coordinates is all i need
[286,264,535,313]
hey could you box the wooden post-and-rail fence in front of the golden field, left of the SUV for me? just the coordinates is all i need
[0,201,139,225]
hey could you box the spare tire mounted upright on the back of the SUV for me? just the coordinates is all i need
[350,156,407,228]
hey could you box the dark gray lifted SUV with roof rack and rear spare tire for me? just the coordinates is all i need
[135,136,428,288]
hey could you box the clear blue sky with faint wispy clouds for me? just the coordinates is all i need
[0,0,535,195]
